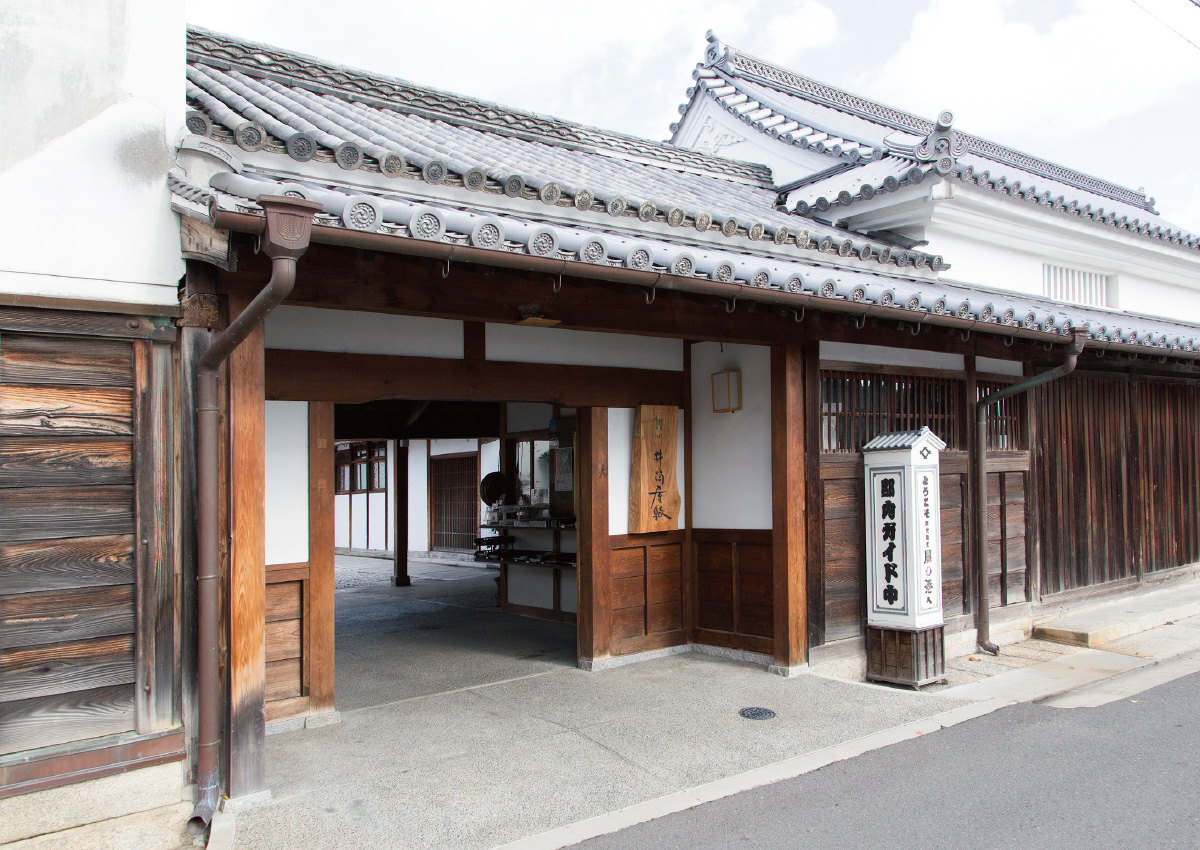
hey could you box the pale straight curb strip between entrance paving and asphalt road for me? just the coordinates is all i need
[492,699,1012,850]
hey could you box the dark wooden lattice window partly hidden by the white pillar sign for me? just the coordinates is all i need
[821,370,965,451]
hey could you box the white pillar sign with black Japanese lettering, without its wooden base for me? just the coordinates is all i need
[863,427,946,630]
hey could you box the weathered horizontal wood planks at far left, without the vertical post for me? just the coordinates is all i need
[0,334,137,753]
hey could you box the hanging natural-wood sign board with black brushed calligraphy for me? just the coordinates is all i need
[629,405,680,534]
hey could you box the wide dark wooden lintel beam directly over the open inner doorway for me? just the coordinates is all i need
[266,349,684,407]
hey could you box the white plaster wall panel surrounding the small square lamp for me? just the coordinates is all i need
[691,342,772,528]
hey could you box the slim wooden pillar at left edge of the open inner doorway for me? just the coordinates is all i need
[305,401,334,713]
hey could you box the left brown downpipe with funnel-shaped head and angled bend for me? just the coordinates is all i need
[187,196,320,836]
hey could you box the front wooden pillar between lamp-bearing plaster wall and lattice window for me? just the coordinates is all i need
[770,343,809,672]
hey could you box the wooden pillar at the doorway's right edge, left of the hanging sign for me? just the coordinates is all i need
[575,407,612,670]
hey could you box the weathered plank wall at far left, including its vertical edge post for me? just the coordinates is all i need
[0,326,179,755]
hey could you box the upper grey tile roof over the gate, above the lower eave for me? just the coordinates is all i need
[186,30,944,269]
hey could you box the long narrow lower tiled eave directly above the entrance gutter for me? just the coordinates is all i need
[168,172,1200,360]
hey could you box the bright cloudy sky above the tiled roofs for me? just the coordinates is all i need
[187,0,1200,233]
